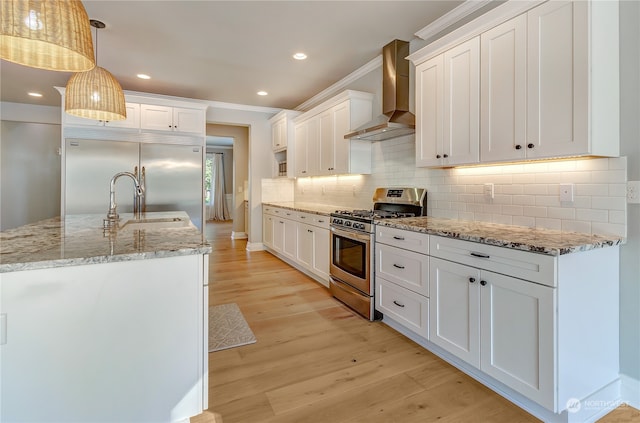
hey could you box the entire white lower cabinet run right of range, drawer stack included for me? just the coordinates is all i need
[375,227,620,422]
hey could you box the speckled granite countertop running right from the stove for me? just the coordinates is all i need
[376,217,624,256]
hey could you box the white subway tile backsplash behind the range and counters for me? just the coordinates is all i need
[288,137,627,235]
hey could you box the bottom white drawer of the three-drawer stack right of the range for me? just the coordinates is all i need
[376,277,429,339]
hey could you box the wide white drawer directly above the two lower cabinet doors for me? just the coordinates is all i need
[429,236,557,287]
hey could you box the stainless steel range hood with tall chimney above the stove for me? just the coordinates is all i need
[344,40,416,141]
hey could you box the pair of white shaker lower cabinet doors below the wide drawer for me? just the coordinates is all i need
[429,257,554,409]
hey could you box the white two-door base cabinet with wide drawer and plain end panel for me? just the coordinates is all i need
[429,236,618,413]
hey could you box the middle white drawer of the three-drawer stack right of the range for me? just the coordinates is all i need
[376,243,429,297]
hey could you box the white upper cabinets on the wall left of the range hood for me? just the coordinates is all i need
[295,90,373,176]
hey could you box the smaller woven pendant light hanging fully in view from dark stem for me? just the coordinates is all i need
[64,19,127,121]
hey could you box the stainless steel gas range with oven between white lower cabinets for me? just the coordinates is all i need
[329,188,427,320]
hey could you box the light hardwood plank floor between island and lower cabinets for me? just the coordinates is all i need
[191,223,640,423]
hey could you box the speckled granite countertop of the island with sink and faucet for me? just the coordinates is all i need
[0,212,211,273]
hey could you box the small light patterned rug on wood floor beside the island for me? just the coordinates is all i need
[209,303,256,352]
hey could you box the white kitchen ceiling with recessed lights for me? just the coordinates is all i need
[0,0,470,109]
